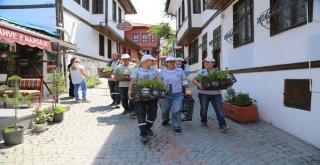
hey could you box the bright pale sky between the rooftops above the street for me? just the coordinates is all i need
[125,0,175,29]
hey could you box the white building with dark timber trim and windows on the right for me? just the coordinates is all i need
[166,0,320,148]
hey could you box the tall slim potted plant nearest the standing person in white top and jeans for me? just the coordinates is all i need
[52,69,67,122]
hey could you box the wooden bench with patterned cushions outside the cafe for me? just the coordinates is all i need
[3,76,43,107]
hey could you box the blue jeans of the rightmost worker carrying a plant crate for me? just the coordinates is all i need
[198,93,227,128]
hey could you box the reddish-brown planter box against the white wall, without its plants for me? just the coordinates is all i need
[222,101,259,123]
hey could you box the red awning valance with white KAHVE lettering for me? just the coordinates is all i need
[0,27,52,52]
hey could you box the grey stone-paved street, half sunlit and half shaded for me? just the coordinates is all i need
[0,80,320,165]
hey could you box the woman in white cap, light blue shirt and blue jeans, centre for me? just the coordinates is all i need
[160,56,188,134]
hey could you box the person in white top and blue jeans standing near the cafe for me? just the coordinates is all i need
[70,59,88,102]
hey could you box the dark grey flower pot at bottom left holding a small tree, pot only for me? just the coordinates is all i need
[2,126,24,146]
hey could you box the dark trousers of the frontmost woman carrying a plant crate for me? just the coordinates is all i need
[134,100,158,136]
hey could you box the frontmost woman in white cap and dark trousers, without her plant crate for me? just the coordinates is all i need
[128,55,161,143]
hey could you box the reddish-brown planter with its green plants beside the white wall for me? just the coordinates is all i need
[222,89,259,123]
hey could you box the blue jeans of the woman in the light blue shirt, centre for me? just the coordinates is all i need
[160,92,184,129]
